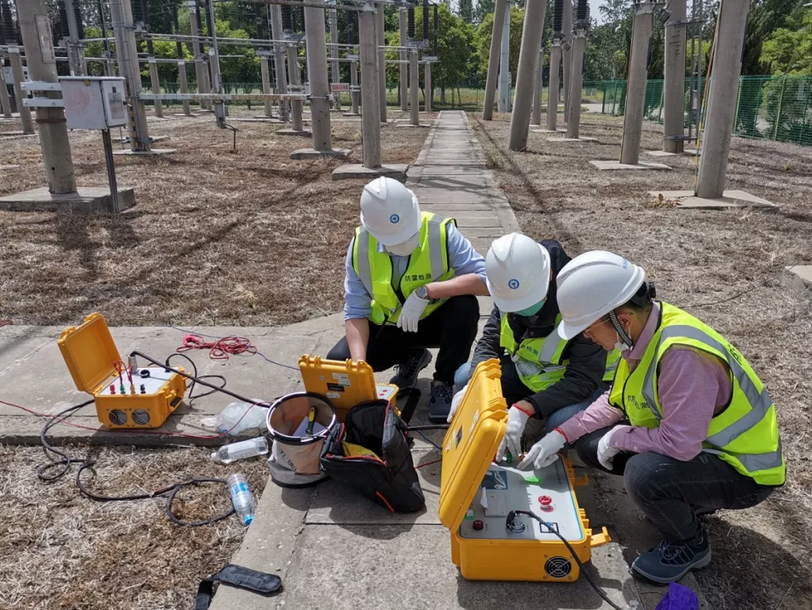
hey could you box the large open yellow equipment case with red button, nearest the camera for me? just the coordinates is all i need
[440,360,609,582]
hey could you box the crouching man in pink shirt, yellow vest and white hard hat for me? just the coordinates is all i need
[524,251,786,583]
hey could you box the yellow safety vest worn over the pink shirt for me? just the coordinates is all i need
[609,303,786,485]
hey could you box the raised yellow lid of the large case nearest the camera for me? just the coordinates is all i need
[440,359,507,531]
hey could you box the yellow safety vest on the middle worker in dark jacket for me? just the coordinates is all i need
[499,314,620,392]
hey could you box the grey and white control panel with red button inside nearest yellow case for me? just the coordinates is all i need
[459,459,584,542]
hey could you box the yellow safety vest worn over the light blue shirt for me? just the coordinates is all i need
[352,212,456,325]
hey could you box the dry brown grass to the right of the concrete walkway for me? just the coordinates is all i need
[473,114,812,610]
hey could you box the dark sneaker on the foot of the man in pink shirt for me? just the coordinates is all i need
[632,531,711,585]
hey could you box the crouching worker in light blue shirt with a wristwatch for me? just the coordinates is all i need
[327,178,488,422]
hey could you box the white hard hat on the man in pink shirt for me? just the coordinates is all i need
[556,250,646,340]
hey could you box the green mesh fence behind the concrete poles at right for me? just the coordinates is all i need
[584,76,812,146]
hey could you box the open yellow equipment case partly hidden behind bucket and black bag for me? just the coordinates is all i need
[299,355,398,422]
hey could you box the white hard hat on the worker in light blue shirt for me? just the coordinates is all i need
[361,176,422,246]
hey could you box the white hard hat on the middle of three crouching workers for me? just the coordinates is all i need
[485,233,550,313]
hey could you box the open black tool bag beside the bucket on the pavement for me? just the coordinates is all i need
[321,400,426,513]
